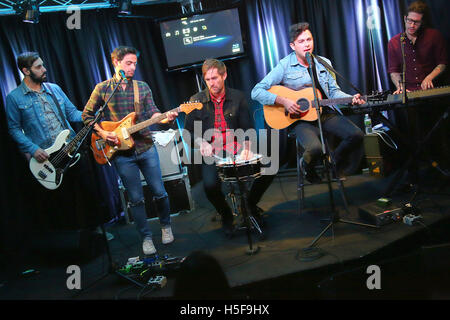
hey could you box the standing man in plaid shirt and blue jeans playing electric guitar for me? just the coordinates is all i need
[82,46,178,255]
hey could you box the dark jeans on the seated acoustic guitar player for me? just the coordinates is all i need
[293,113,364,175]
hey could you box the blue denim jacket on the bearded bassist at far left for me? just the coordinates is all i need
[6,81,82,156]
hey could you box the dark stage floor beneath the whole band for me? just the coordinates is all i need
[0,170,450,300]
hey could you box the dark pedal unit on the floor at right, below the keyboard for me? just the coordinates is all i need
[358,202,405,227]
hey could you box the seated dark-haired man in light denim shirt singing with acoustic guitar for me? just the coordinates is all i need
[252,22,365,182]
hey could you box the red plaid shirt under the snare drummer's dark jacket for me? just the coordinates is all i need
[210,92,241,155]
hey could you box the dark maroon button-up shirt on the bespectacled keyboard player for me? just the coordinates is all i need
[388,28,448,91]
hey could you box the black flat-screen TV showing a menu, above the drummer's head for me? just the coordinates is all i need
[160,8,245,71]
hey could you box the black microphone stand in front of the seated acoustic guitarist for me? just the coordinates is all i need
[302,52,377,261]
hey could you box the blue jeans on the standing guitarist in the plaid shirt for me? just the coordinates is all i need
[113,146,170,239]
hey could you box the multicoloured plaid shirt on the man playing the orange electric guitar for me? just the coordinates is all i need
[82,77,160,154]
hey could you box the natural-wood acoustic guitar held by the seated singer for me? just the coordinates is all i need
[264,86,367,130]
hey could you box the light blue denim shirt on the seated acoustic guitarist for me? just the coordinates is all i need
[252,52,352,113]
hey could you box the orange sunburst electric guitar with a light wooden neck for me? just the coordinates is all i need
[91,102,203,164]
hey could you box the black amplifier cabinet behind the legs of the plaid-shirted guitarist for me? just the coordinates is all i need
[119,167,194,223]
